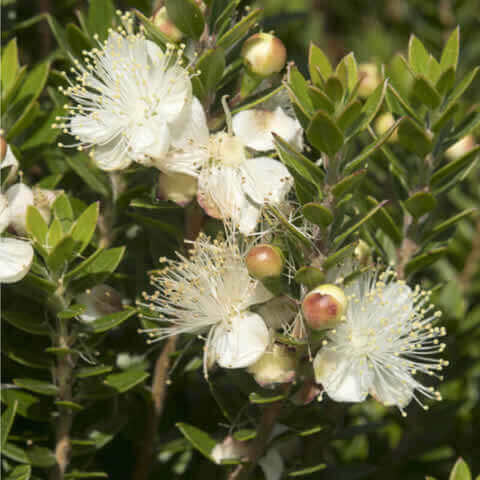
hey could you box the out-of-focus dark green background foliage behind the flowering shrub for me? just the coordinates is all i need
[1,0,480,480]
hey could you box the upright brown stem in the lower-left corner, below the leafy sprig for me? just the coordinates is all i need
[50,320,74,480]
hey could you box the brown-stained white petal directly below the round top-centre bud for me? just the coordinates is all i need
[232,107,303,152]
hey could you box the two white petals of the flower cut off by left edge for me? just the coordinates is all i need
[0,194,33,283]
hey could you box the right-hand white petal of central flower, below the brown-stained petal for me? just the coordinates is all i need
[242,157,293,204]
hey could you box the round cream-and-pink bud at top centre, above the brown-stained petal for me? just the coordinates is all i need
[241,33,287,77]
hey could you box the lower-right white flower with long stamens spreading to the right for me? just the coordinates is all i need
[314,270,448,414]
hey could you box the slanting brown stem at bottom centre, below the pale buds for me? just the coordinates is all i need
[228,400,283,480]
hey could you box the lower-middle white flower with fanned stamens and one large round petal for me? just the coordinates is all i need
[140,235,272,374]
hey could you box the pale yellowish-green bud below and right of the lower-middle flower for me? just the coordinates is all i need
[248,344,296,387]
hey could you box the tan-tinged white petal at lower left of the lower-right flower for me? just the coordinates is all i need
[313,348,373,402]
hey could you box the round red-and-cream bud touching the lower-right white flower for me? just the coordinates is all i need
[302,284,347,330]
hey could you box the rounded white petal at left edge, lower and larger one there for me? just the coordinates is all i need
[0,238,33,283]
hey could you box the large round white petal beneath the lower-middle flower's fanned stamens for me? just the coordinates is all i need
[211,312,269,368]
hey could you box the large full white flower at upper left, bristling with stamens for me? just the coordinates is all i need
[60,20,197,170]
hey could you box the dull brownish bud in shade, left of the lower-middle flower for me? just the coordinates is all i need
[76,284,122,323]
